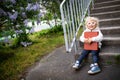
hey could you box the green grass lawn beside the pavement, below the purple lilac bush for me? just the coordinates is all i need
[0,33,64,80]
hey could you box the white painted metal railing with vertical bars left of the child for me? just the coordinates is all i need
[60,0,94,52]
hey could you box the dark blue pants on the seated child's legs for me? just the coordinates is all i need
[78,49,100,64]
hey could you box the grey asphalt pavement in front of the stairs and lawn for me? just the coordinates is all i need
[25,46,120,80]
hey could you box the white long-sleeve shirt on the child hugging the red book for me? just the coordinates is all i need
[80,27,103,48]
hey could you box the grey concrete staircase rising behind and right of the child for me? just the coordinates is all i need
[91,0,120,55]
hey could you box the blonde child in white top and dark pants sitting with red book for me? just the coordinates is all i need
[73,17,103,74]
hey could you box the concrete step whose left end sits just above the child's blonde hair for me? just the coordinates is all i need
[91,5,120,14]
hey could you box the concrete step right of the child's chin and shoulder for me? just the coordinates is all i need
[100,26,120,35]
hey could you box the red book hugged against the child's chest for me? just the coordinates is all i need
[84,32,98,50]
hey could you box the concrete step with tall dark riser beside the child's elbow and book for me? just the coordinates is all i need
[101,35,120,55]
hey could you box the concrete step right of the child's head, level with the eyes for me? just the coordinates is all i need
[100,18,120,27]
